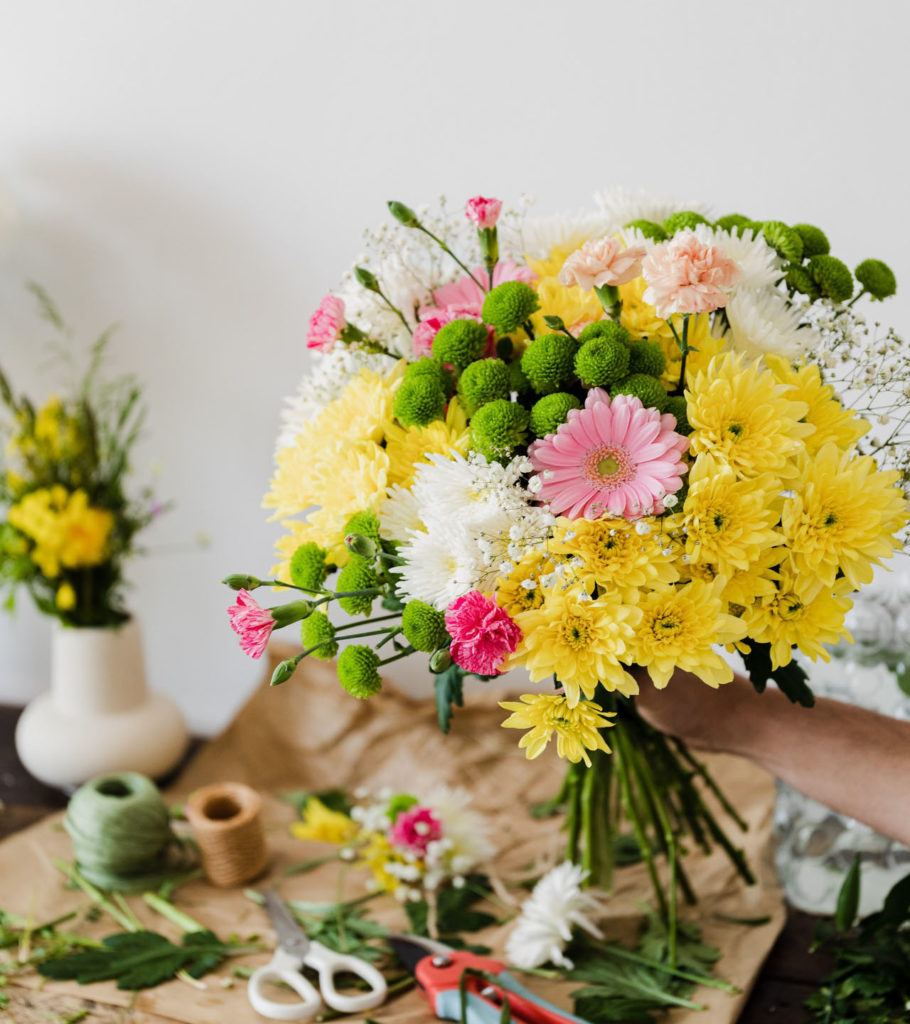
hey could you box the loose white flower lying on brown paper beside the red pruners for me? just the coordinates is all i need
[506,861,605,970]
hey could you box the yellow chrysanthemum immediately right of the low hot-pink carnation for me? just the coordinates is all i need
[506,589,641,708]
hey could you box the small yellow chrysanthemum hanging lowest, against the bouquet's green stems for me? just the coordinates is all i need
[500,693,615,768]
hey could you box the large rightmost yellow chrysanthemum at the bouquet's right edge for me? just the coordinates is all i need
[781,441,907,590]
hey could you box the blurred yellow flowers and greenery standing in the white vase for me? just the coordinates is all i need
[0,288,161,627]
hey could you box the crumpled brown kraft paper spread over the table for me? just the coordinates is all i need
[0,648,784,1024]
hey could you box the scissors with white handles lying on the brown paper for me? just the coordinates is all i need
[248,890,388,1021]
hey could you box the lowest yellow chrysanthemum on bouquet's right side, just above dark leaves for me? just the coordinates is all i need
[745,562,853,669]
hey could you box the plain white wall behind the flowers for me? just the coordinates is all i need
[0,0,910,731]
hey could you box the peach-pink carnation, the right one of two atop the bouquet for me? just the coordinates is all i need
[642,231,742,319]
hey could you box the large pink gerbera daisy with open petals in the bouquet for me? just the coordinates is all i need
[528,388,689,519]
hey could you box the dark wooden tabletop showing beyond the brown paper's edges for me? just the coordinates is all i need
[0,705,829,1024]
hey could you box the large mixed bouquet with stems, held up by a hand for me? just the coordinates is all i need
[225,194,910,954]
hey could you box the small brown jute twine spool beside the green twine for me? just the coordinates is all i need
[185,782,268,889]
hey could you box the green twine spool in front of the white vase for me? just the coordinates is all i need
[63,772,174,892]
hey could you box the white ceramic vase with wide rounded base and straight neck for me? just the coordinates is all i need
[15,620,187,788]
